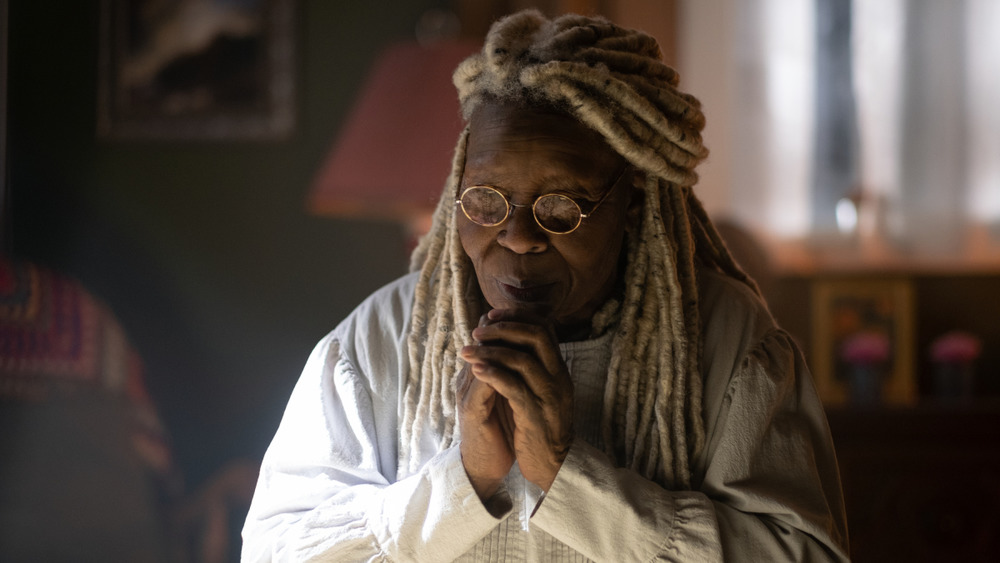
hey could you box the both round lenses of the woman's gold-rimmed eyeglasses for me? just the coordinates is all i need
[461,186,581,233]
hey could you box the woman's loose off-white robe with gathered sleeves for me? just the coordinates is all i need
[242,271,847,562]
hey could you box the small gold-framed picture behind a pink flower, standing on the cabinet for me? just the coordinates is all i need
[810,278,917,406]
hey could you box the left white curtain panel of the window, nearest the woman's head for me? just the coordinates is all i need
[732,0,815,238]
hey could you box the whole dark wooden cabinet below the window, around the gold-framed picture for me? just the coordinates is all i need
[765,268,1000,563]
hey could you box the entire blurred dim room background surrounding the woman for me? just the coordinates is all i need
[0,0,1000,562]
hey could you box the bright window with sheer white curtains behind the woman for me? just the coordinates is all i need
[680,0,1000,266]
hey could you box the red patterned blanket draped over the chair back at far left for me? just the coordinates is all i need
[0,259,175,480]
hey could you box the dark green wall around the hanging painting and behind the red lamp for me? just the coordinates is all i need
[8,0,442,485]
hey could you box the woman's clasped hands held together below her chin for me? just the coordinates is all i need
[457,309,573,501]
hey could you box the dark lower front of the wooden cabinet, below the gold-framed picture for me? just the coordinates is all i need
[827,403,1000,563]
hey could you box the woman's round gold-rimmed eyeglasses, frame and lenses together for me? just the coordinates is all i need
[455,166,628,235]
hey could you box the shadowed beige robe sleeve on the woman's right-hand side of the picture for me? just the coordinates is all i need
[531,329,848,562]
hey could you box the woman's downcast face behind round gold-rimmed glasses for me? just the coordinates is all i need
[457,104,640,340]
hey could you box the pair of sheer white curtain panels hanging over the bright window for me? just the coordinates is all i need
[728,0,1000,255]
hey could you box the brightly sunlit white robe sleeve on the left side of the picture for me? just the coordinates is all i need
[242,335,508,562]
